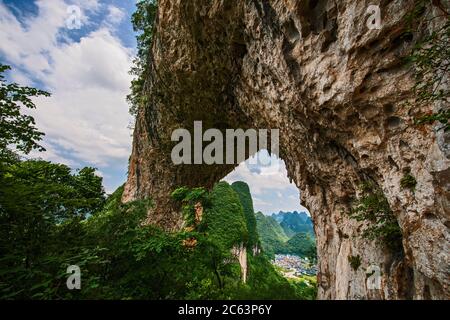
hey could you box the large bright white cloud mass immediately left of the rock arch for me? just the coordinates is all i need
[29,29,131,165]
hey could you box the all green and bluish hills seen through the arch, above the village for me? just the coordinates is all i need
[211,181,315,258]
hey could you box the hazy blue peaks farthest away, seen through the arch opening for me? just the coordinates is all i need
[272,211,314,237]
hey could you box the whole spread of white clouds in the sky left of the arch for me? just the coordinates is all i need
[0,0,133,175]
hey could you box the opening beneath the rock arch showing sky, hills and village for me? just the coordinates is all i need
[222,149,317,286]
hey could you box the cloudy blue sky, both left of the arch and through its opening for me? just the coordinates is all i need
[0,0,308,214]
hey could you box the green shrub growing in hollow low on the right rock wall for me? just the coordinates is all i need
[350,182,403,252]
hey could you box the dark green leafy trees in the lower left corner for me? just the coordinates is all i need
[0,160,104,299]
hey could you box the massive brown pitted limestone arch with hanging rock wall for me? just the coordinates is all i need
[123,0,450,299]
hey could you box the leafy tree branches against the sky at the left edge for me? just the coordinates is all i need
[0,64,50,161]
